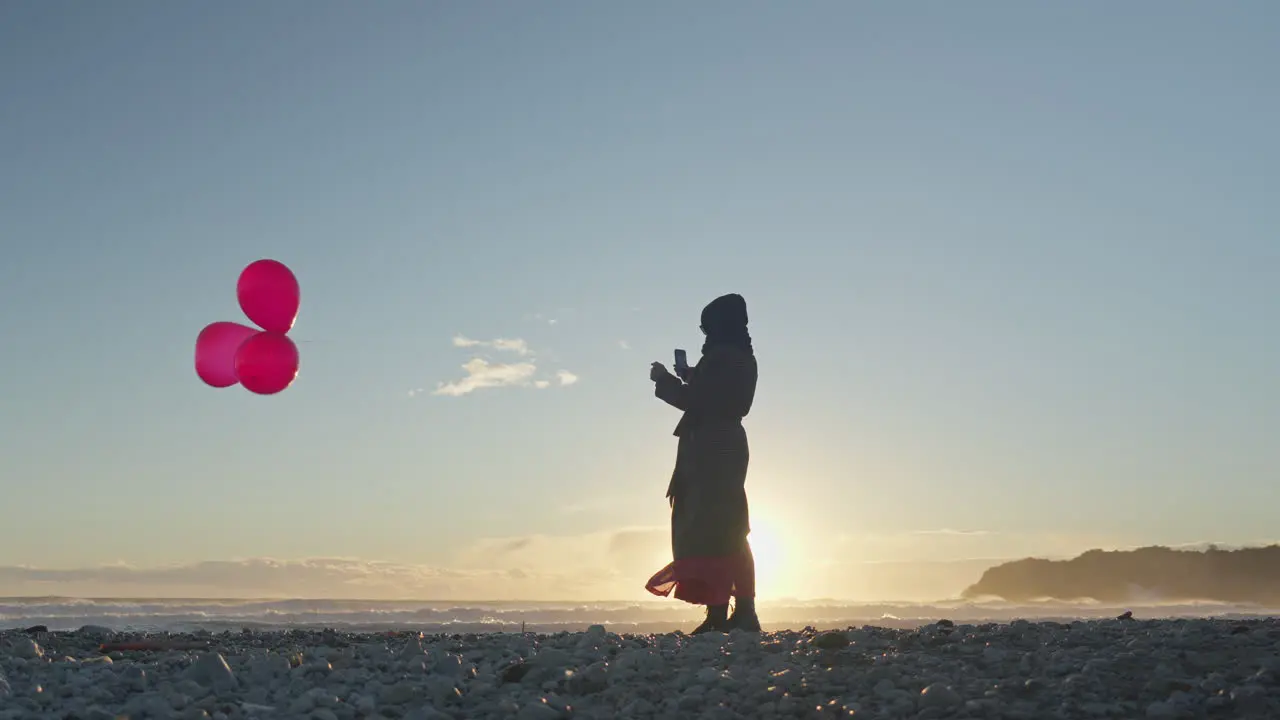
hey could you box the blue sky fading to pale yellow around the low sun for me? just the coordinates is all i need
[0,0,1280,597]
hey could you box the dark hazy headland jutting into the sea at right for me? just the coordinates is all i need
[961,544,1280,606]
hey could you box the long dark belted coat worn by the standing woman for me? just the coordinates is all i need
[654,346,758,560]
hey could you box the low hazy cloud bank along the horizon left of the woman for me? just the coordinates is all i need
[0,527,671,601]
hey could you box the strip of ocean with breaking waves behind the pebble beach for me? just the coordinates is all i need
[0,597,1280,633]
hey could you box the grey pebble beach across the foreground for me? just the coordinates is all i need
[0,619,1280,720]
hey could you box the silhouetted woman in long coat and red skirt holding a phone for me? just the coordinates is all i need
[646,288,760,634]
